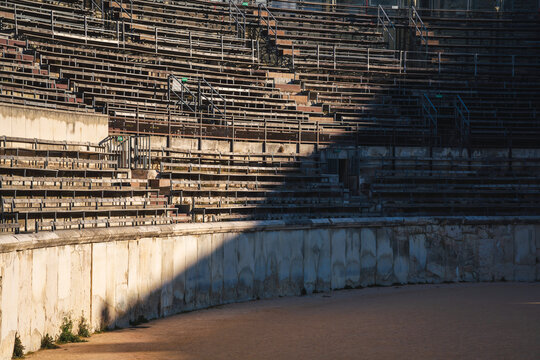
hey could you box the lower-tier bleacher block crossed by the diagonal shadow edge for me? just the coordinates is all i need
[152,149,369,220]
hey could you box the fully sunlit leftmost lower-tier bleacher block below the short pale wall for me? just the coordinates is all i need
[0,137,187,231]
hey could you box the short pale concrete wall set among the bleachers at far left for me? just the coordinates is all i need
[0,105,109,143]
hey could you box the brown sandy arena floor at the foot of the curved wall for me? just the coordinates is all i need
[28,283,540,360]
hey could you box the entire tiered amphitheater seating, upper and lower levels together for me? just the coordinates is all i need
[0,0,540,231]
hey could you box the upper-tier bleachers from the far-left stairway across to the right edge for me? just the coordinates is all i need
[2,0,539,146]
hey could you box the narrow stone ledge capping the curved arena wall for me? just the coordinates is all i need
[0,216,540,253]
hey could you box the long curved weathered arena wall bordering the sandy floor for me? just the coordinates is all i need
[0,217,540,359]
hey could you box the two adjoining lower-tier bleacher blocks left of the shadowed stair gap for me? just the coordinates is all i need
[0,138,368,231]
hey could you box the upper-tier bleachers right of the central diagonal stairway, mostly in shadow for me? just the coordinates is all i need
[254,1,540,147]
